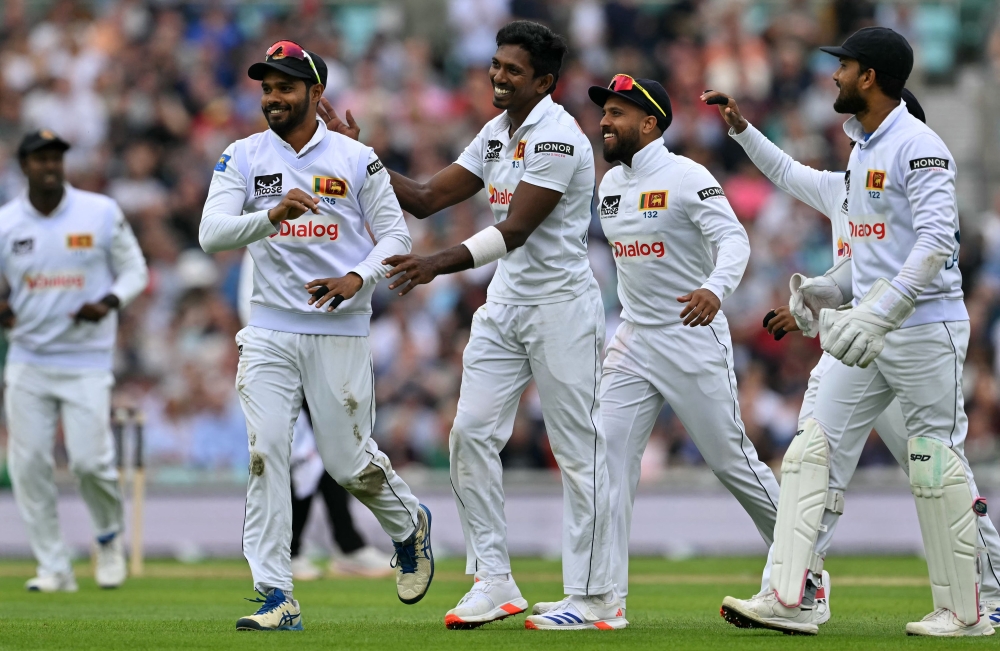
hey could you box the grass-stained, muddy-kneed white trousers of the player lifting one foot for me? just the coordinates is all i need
[236,326,418,591]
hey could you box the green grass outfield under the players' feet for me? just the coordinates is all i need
[0,557,1000,651]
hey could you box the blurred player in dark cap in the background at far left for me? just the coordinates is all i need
[0,130,149,592]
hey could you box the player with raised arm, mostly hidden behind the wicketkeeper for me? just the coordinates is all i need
[702,88,1000,627]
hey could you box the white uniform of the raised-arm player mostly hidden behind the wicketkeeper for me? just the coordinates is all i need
[729,119,1000,600]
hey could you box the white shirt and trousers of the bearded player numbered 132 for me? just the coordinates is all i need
[599,140,778,595]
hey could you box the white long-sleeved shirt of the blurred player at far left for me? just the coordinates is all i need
[0,185,149,369]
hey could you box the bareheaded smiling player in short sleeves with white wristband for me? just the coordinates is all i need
[329,21,628,630]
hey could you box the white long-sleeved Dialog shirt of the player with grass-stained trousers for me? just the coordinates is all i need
[199,120,410,337]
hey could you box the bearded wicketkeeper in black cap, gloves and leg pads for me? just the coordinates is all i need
[725,27,993,637]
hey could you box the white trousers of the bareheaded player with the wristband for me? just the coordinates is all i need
[450,283,613,595]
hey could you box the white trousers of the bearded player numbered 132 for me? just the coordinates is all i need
[601,312,778,595]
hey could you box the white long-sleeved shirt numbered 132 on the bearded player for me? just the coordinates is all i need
[598,140,750,326]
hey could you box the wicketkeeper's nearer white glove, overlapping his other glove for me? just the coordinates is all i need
[819,278,915,368]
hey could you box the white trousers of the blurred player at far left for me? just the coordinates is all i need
[4,362,123,576]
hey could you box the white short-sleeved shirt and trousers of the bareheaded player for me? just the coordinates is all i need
[450,97,612,595]
